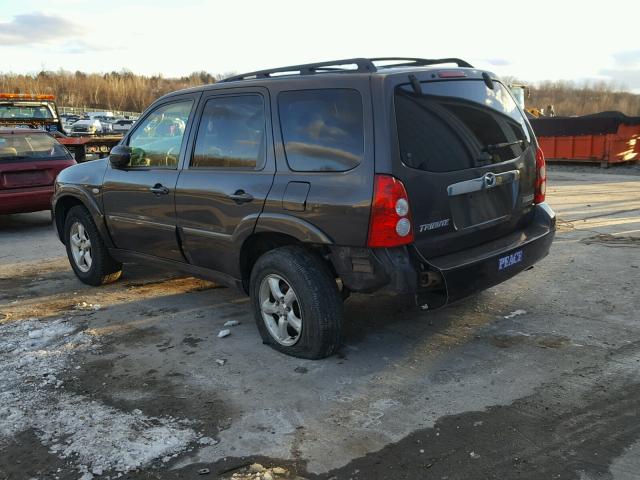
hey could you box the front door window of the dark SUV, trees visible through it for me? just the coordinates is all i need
[129,100,193,168]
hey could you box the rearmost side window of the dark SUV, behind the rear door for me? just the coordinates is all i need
[278,89,364,172]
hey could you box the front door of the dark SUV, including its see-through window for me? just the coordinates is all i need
[103,95,197,261]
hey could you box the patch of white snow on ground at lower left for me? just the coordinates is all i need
[0,319,199,479]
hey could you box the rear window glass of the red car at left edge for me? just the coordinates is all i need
[0,133,70,163]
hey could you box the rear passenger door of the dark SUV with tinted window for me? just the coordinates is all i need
[176,89,275,278]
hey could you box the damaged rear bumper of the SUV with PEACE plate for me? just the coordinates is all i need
[331,203,556,309]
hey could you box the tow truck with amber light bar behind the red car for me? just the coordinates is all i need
[0,93,122,163]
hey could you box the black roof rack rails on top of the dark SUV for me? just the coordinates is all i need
[220,57,473,82]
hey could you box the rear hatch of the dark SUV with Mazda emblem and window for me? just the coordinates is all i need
[394,75,536,258]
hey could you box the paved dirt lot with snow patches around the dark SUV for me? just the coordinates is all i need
[0,167,640,480]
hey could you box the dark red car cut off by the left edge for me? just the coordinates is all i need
[0,128,76,215]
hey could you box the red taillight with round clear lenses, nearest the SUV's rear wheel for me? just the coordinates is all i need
[367,175,413,247]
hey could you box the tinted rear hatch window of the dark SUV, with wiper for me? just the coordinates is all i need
[395,80,531,172]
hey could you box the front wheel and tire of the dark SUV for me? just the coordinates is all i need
[64,205,122,287]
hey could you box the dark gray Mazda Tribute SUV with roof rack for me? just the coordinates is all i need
[53,58,555,358]
